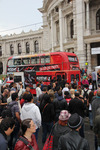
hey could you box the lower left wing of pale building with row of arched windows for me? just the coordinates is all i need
[0,29,43,74]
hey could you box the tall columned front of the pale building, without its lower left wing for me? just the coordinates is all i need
[39,0,100,72]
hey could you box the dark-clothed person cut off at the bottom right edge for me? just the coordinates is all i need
[94,108,100,150]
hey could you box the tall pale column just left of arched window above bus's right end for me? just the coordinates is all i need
[59,4,63,51]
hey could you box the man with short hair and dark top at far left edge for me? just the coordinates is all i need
[0,89,9,116]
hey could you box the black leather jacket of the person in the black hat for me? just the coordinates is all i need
[58,130,90,150]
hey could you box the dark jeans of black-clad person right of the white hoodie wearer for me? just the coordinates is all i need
[42,122,53,144]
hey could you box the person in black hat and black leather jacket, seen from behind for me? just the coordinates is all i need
[58,113,90,150]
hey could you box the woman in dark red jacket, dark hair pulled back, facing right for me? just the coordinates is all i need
[14,119,39,150]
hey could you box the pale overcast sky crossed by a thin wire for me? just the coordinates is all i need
[0,0,43,35]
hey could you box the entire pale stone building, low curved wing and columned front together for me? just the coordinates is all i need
[0,0,100,74]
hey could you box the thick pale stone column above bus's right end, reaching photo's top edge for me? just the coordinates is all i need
[76,0,85,68]
